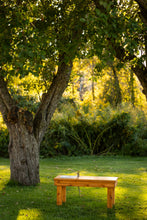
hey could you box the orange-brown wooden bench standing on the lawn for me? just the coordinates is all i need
[54,175,118,208]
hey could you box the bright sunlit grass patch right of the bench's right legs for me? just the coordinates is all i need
[115,175,147,219]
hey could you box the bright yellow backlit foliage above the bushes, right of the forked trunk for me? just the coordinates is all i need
[64,57,147,111]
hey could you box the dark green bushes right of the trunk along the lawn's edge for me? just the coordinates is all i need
[41,106,147,157]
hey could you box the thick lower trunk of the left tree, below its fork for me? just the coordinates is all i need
[8,107,40,185]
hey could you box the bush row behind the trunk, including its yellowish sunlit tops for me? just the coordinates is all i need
[0,100,147,157]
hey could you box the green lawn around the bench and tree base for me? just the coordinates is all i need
[0,156,147,220]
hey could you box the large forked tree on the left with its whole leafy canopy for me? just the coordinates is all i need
[0,0,147,185]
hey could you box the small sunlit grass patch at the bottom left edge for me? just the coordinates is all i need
[16,209,43,220]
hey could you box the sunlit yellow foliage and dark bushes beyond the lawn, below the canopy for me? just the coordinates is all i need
[0,57,147,157]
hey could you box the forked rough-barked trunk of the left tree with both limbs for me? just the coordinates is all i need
[0,59,72,185]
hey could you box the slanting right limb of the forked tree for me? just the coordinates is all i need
[34,58,72,142]
